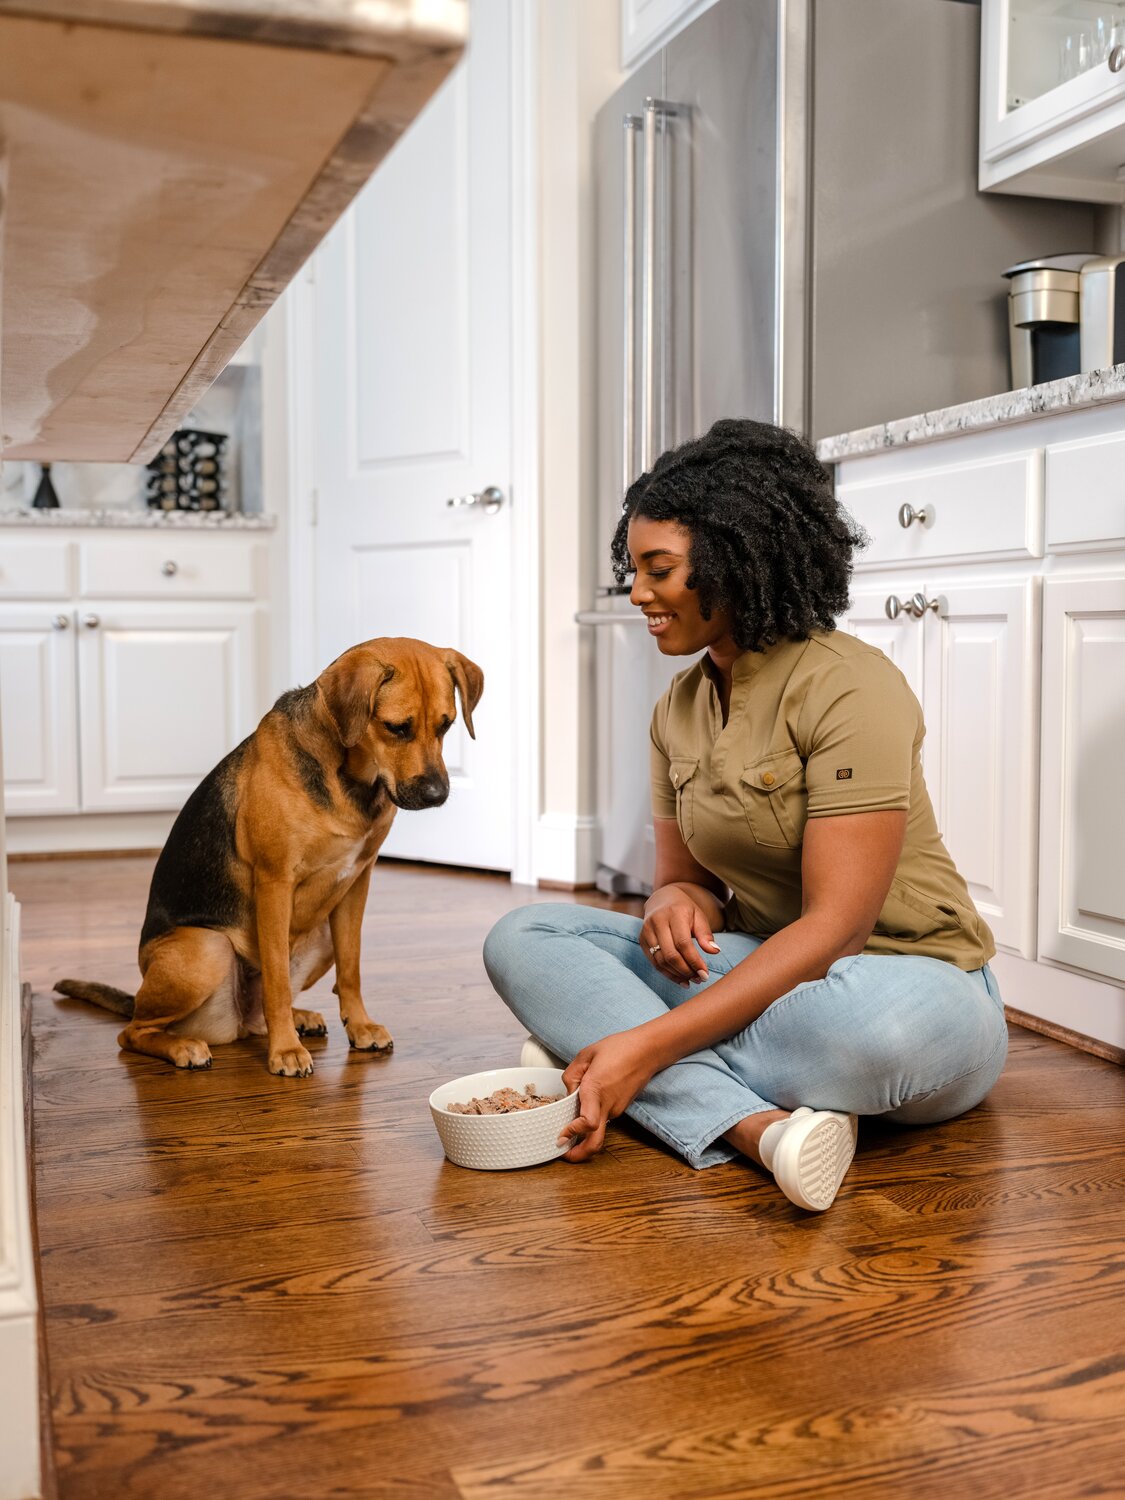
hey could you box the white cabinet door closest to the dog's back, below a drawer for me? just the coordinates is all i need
[78,605,258,812]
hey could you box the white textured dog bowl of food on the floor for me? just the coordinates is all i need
[429,1068,578,1172]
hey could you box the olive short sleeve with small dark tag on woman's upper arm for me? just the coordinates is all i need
[801,651,926,818]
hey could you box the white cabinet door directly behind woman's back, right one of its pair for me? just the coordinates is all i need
[923,579,1038,959]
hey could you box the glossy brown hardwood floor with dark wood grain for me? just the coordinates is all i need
[11,860,1125,1500]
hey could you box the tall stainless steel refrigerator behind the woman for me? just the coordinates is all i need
[579,0,1098,893]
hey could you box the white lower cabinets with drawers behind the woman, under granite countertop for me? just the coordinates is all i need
[836,401,1125,1058]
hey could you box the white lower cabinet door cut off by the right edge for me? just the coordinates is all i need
[1040,578,1125,983]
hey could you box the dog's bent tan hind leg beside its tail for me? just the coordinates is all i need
[117,927,237,1068]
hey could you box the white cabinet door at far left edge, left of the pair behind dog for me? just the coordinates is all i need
[0,606,78,818]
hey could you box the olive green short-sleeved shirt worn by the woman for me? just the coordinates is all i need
[651,630,996,969]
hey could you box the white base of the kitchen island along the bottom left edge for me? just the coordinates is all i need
[0,893,41,1500]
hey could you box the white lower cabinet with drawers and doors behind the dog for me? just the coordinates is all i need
[0,528,267,851]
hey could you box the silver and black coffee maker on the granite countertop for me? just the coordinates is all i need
[1004,251,1125,390]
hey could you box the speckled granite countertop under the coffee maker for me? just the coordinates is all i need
[816,365,1125,464]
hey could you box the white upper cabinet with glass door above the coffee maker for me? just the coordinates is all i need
[980,0,1125,203]
